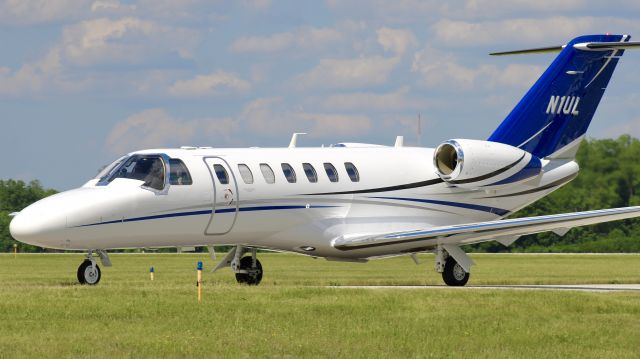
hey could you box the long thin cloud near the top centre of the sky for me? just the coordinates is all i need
[231,26,343,52]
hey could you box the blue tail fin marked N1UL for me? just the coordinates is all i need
[489,35,630,158]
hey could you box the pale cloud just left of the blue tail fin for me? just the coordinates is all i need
[411,47,544,90]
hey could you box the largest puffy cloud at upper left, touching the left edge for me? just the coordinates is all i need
[0,16,201,96]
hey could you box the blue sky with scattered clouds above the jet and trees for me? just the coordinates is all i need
[0,0,640,190]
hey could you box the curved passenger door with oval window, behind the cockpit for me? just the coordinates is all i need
[204,157,239,235]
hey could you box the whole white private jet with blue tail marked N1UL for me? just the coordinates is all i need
[10,34,640,286]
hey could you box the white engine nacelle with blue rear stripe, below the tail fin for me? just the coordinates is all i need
[433,139,542,188]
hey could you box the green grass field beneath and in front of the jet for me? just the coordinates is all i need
[0,254,640,358]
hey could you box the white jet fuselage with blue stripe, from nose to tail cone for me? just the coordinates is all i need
[11,145,578,259]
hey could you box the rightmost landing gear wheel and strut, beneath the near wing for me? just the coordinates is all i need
[435,246,474,287]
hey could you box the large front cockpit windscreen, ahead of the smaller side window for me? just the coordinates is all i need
[109,156,165,191]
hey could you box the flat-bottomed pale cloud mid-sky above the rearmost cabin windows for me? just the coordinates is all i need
[296,56,400,88]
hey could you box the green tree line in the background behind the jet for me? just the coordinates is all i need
[0,135,640,252]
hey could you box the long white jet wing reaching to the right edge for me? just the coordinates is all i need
[333,206,640,251]
